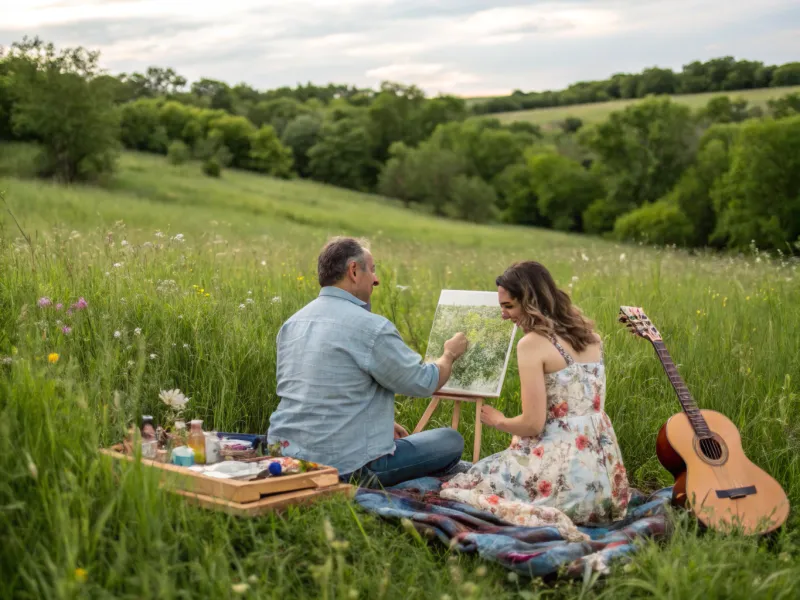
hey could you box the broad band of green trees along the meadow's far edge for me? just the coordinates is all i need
[0,38,800,251]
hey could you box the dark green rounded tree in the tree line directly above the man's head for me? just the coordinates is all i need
[308,118,378,191]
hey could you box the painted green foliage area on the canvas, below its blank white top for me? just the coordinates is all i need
[425,305,514,394]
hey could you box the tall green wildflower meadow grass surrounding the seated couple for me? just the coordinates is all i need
[0,146,800,599]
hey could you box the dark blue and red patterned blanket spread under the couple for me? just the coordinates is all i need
[355,477,672,578]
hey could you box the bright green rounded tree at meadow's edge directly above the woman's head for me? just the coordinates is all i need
[528,153,604,231]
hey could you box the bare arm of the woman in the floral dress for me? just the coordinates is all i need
[481,335,547,437]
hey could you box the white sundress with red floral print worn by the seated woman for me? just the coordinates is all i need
[441,339,629,541]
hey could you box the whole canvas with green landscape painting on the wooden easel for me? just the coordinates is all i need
[425,290,517,398]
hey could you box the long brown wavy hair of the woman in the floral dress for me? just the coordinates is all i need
[495,260,597,352]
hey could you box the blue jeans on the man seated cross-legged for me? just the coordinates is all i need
[340,427,464,487]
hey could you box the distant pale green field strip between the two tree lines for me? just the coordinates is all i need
[489,86,800,128]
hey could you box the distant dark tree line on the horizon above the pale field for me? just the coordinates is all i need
[472,56,800,115]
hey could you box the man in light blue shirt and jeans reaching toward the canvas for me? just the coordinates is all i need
[267,238,467,486]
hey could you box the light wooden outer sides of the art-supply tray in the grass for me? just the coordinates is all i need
[100,448,339,503]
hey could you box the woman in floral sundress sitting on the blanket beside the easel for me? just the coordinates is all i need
[441,261,628,540]
